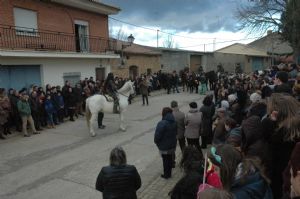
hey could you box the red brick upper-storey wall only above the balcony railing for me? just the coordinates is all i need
[0,0,108,38]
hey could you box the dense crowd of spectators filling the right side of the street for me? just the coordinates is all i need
[154,64,300,199]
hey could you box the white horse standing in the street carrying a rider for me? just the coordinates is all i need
[86,80,134,137]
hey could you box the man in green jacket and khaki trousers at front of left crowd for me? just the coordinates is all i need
[17,94,39,137]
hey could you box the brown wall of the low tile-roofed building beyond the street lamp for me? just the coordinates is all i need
[110,54,161,78]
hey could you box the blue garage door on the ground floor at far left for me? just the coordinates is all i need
[0,65,41,90]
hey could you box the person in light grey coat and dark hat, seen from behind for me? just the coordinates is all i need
[184,102,202,151]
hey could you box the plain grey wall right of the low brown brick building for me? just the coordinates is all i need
[161,51,190,72]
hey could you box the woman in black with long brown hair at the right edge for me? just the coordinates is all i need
[263,93,300,199]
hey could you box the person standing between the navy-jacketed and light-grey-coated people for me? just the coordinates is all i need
[171,101,185,152]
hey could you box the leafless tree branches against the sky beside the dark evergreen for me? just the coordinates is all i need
[236,0,288,35]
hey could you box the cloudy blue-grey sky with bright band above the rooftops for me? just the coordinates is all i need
[102,0,257,51]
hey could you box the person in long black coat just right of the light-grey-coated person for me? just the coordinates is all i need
[200,95,215,149]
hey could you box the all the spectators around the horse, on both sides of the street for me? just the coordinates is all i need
[0,64,300,199]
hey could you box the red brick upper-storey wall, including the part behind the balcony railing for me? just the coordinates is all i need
[0,0,108,53]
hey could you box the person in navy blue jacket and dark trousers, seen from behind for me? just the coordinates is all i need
[154,107,177,179]
